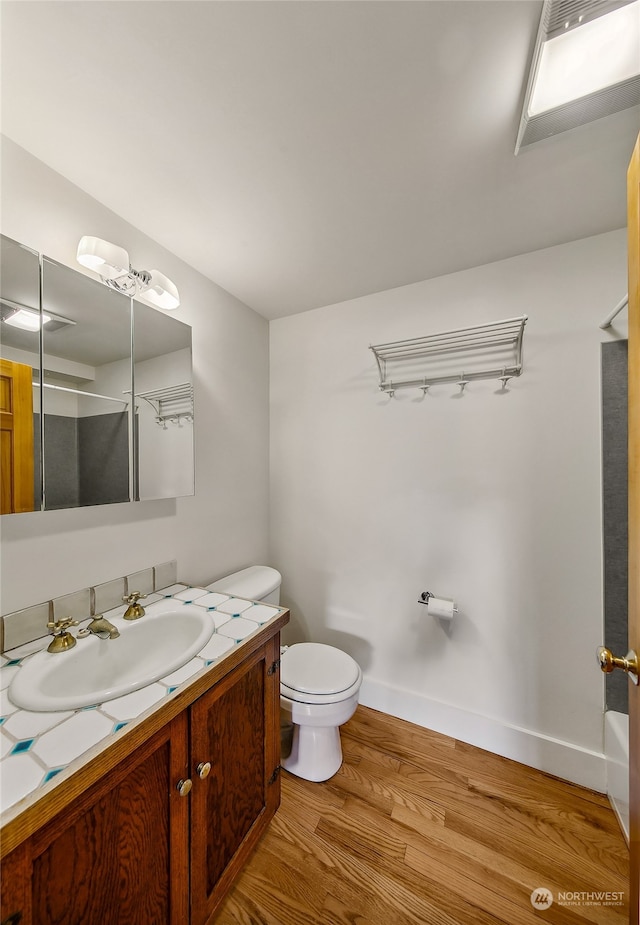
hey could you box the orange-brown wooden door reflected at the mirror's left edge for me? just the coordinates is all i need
[0,359,34,514]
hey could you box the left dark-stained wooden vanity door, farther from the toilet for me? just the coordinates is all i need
[31,715,189,925]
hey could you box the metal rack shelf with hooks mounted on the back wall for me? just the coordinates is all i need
[369,315,527,395]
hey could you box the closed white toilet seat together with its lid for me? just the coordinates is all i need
[280,642,362,704]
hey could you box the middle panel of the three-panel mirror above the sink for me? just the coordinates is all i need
[42,257,131,511]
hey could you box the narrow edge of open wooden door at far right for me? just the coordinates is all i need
[627,135,640,925]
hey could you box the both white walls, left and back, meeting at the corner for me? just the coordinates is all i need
[0,142,626,788]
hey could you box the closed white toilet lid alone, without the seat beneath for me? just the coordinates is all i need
[280,642,359,694]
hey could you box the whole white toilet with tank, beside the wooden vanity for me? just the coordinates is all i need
[207,565,362,781]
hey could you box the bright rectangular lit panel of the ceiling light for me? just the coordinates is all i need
[528,0,640,116]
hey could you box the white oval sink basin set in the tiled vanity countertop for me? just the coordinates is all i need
[9,601,215,712]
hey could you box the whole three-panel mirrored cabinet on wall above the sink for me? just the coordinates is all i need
[0,237,194,513]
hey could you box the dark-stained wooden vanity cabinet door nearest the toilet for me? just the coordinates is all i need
[190,635,280,925]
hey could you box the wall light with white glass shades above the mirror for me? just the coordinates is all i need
[77,235,180,311]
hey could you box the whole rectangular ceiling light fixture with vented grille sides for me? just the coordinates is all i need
[515,0,640,154]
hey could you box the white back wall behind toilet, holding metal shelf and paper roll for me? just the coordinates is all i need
[270,231,626,789]
